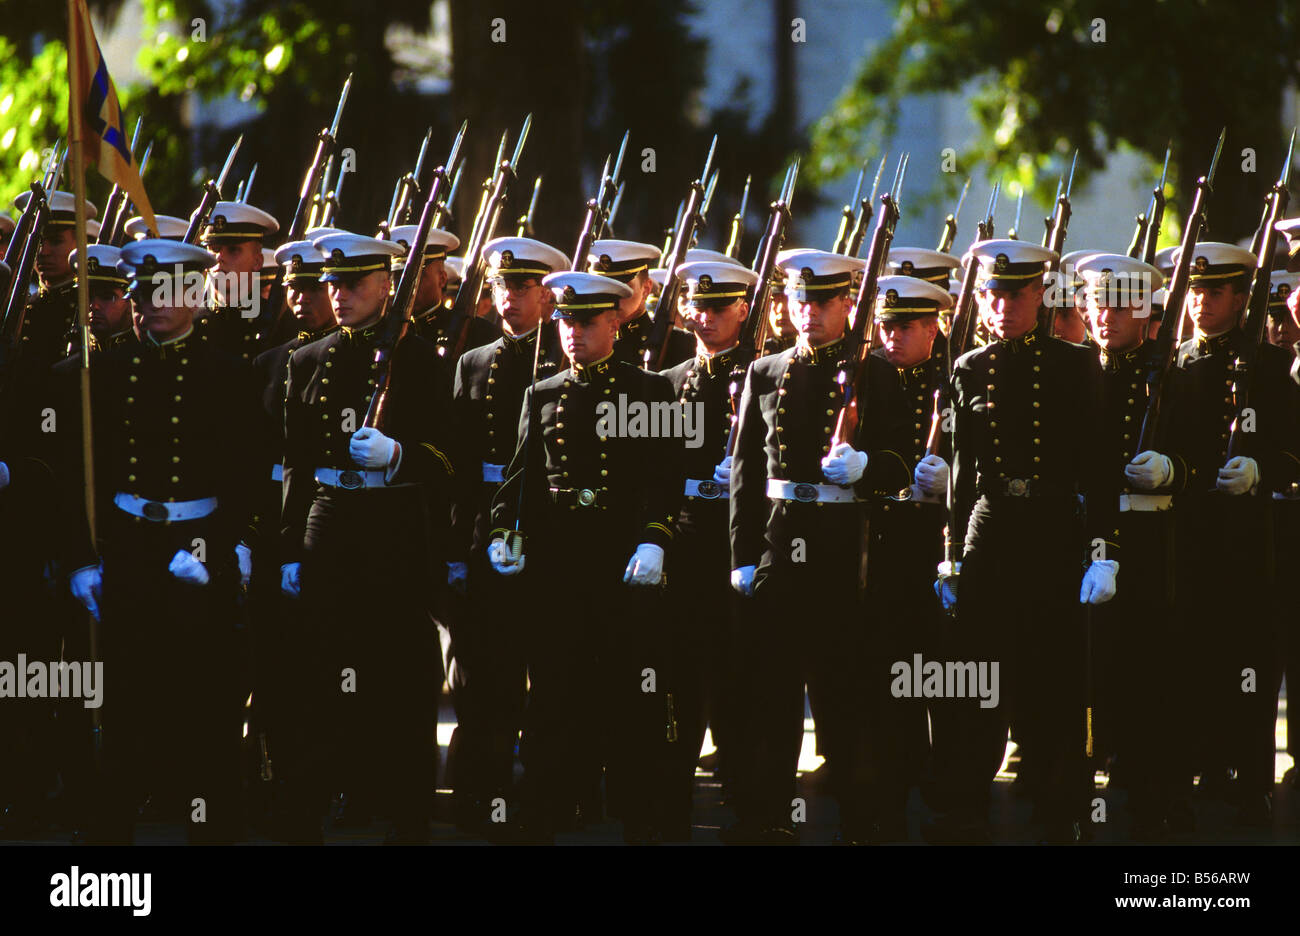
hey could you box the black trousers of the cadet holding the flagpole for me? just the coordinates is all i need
[90,508,243,842]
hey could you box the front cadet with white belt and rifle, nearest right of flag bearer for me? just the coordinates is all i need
[280,233,455,842]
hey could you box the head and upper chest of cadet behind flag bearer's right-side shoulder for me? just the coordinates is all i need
[198,202,280,361]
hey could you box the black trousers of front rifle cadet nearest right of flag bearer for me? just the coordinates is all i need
[300,486,446,833]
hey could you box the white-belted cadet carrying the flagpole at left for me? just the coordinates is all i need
[64,239,255,841]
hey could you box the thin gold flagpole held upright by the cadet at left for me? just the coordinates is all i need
[68,0,99,735]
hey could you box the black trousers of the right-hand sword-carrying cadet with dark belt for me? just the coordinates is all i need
[946,497,1092,823]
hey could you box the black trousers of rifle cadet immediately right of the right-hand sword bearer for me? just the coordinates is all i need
[1092,511,1192,822]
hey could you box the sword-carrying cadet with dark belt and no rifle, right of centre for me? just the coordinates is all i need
[927,241,1119,842]
